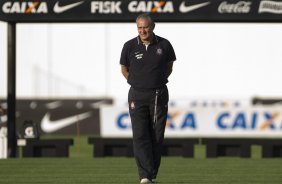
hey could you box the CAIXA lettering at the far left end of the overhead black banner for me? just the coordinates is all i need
[2,1,48,14]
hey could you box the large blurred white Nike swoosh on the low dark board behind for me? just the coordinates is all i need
[41,112,92,133]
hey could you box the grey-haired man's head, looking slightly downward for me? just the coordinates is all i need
[137,18,154,41]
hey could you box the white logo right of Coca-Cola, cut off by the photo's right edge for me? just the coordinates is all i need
[259,1,282,14]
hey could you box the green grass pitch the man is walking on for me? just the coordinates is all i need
[0,137,282,184]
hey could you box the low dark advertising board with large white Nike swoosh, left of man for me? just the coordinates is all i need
[0,98,113,136]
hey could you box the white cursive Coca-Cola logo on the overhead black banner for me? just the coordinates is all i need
[218,1,252,13]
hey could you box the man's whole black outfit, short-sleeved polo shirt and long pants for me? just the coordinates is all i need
[120,35,176,179]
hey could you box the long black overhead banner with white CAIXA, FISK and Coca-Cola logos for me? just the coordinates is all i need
[0,0,282,22]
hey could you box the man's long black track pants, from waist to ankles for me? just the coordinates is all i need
[128,86,168,179]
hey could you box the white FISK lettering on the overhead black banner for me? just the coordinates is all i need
[91,1,122,14]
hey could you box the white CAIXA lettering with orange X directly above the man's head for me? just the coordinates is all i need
[128,1,174,13]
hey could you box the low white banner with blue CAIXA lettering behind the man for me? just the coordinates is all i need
[100,106,282,138]
